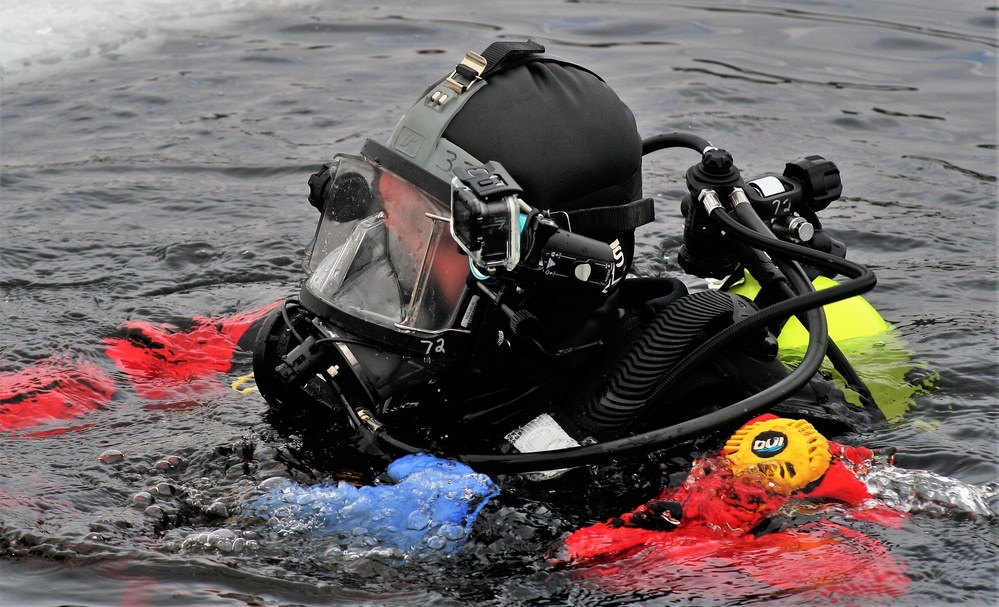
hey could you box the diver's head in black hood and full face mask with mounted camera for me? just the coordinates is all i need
[254,42,652,412]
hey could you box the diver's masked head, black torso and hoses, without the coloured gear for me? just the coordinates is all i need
[246,41,881,479]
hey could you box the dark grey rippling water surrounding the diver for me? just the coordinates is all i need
[0,0,999,606]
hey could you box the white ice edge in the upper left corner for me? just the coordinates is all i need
[0,0,298,79]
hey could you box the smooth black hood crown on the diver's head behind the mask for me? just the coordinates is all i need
[444,59,642,211]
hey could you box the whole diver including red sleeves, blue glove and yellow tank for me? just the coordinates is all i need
[0,41,964,576]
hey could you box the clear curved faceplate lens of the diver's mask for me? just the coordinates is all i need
[306,156,469,332]
